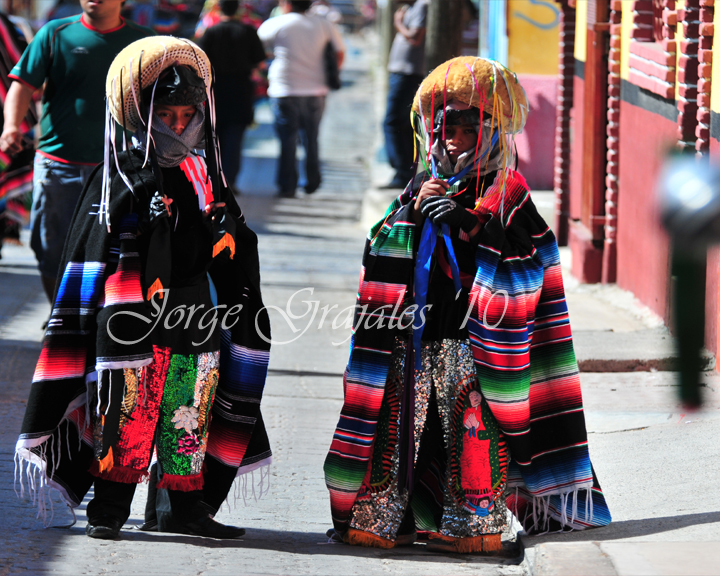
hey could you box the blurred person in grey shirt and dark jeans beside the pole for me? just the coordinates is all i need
[383,0,428,188]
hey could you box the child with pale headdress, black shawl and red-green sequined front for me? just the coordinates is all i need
[17,36,270,539]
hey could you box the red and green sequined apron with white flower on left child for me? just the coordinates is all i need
[92,282,220,491]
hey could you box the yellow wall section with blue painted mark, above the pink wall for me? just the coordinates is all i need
[507,0,560,76]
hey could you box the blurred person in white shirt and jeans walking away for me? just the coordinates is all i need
[258,0,345,197]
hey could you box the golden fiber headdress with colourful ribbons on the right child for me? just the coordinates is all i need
[411,56,529,209]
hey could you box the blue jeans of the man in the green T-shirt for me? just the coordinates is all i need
[30,152,94,279]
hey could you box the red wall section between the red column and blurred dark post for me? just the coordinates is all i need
[617,102,677,323]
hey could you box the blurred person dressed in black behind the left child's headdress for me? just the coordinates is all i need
[198,0,265,192]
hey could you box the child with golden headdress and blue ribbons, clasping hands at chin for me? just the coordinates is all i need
[325,57,610,552]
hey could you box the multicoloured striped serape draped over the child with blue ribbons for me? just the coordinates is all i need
[324,170,610,532]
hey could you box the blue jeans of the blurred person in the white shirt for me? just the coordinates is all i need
[270,96,325,195]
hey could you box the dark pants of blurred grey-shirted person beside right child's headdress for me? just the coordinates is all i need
[383,73,423,186]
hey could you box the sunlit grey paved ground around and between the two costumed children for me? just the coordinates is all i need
[0,30,720,576]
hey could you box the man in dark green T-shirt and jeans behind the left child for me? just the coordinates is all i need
[0,0,154,302]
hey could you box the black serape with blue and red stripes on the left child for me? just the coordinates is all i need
[16,151,271,511]
